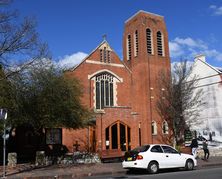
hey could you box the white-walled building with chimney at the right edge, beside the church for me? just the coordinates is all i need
[191,55,222,147]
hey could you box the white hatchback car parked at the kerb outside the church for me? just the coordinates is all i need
[122,144,197,173]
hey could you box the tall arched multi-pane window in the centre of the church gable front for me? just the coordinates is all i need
[96,73,114,109]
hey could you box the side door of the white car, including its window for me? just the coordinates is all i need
[161,145,185,168]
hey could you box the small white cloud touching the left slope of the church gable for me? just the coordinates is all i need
[57,52,88,69]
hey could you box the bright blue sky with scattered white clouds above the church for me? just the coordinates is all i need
[6,0,222,67]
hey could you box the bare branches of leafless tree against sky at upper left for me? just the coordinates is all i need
[0,0,49,81]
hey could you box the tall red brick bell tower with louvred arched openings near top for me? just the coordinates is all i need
[123,11,170,144]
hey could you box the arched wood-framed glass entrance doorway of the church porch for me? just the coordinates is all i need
[105,121,131,151]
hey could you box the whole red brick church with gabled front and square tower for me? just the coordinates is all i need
[62,11,170,157]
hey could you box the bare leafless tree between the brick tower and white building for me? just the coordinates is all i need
[156,60,204,143]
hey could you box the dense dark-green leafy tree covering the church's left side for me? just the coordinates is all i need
[11,60,92,130]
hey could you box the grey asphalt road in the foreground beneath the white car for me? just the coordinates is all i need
[83,167,222,179]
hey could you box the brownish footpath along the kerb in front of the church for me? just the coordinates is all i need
[0,156,222,179]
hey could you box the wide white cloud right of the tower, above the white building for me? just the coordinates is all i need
[169,37,222,61]
